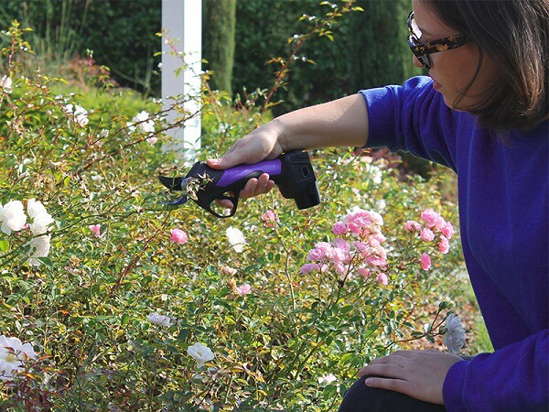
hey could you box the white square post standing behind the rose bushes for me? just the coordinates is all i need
[162,0,202,160]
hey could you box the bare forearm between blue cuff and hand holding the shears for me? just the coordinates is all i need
[273,94,368,151]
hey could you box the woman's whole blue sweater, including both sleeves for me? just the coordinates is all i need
[360,77,549,412]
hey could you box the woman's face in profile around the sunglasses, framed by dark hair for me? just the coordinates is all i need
[413,0,498,111]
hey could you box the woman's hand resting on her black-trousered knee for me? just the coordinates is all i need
[358,350,462,405]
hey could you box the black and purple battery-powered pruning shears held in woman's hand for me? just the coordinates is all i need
[159,150,320,218]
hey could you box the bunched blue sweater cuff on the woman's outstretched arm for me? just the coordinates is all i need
[359,87,397,147]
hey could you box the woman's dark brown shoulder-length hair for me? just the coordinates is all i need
[425,0,549,130]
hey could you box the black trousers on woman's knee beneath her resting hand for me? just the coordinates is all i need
[339,376,446,412]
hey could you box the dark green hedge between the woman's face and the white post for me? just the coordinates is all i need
[233,0,420,112]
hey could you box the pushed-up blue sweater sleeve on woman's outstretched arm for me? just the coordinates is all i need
[359,76,457,171]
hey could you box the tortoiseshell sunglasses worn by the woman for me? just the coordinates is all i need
[408,11,471,69]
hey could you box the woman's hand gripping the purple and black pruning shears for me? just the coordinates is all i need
[206,119,284,209]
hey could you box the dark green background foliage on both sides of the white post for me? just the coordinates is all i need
[0,0,419,114]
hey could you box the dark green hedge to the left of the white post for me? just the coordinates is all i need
[0,0,162,95]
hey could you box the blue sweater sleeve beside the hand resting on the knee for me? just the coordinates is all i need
[443,330,549,412]
